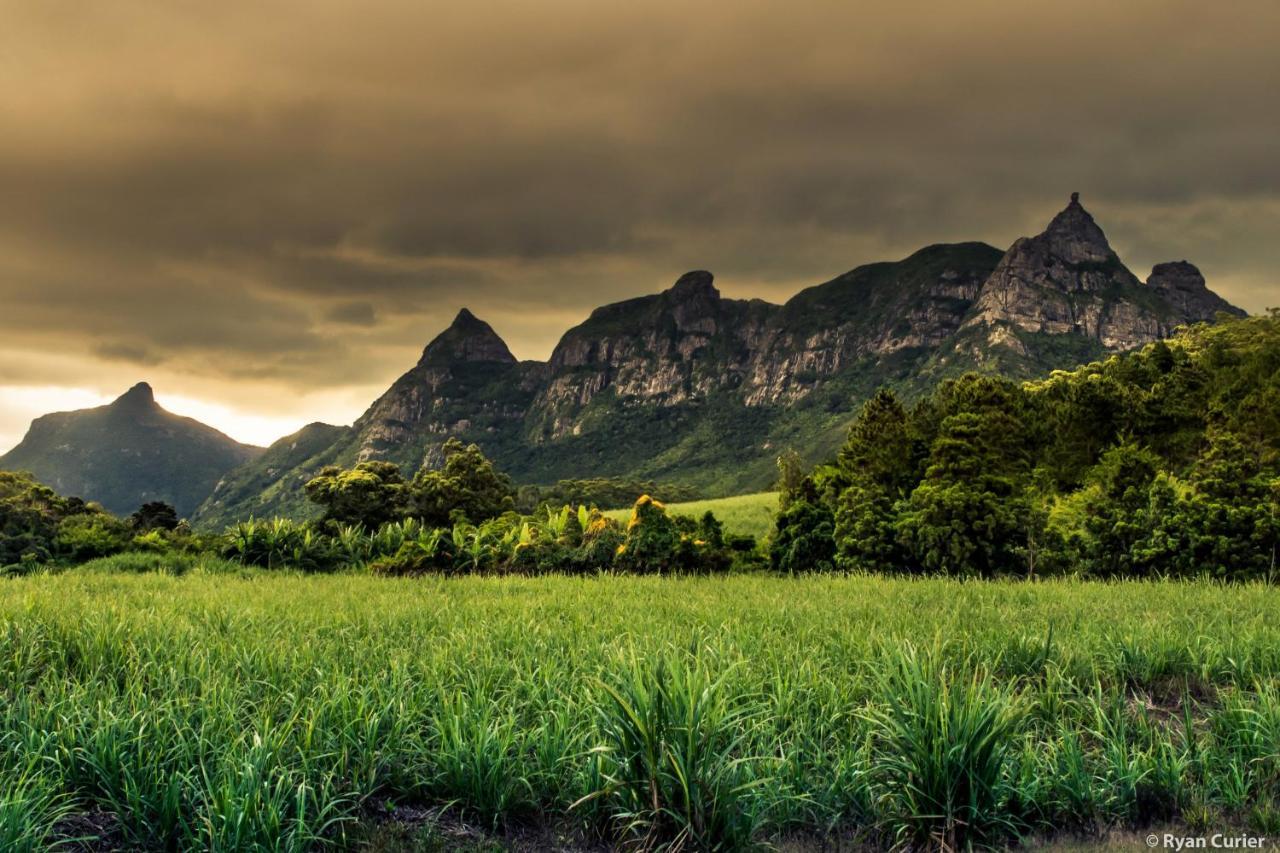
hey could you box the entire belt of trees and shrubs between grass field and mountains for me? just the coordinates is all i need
[10,314,1280,581]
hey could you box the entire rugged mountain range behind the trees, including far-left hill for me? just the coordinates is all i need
[0,193,1243,526]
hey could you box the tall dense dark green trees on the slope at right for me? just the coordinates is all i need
[772,313,1280,580]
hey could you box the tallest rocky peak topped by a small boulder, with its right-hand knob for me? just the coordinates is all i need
[964,193,1230,351]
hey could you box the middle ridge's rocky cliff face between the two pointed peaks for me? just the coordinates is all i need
[530,243,1000,441]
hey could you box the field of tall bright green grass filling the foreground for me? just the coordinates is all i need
[0,556,1280,850]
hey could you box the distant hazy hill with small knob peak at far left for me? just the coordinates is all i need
[0,382,262,516]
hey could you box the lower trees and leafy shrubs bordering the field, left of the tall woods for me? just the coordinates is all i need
[0,439,762,575]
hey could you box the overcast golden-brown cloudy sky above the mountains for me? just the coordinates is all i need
[0,0,1280,451]
